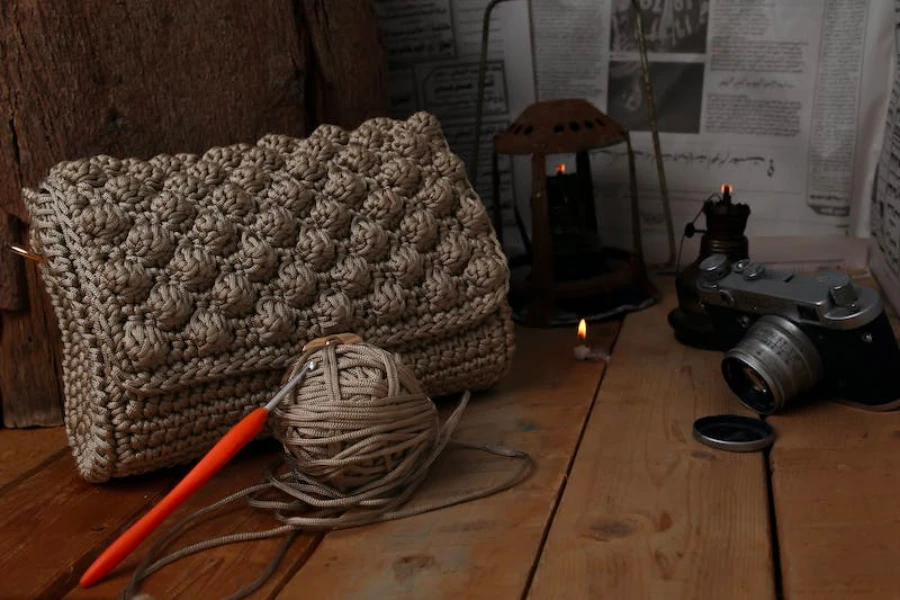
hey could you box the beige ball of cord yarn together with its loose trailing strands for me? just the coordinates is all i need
[120,343,534,600]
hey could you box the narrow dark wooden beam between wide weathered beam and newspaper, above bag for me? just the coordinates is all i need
[298,0,390,128]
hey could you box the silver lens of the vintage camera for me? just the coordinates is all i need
[722,315,822,415]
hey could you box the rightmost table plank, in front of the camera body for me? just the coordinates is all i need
[769,278,900,600]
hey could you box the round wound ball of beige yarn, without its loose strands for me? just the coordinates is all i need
[270,343,441,506]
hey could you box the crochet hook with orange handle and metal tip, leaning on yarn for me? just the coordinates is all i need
[79,361,315,588]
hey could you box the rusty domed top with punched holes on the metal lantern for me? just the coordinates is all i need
[494,99,628,154]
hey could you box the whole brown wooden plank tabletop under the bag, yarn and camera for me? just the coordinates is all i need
[0,279,900,600]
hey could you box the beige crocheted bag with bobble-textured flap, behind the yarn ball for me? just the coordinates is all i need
[24,113,514,482]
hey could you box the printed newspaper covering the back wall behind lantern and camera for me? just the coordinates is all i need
[377,0,900,263]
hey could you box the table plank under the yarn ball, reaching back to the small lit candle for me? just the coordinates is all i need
[283,323,618,600]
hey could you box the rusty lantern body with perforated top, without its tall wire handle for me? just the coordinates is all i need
[492,99,648,326]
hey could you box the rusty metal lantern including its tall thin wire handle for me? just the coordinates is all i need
[469,0,675,326]
